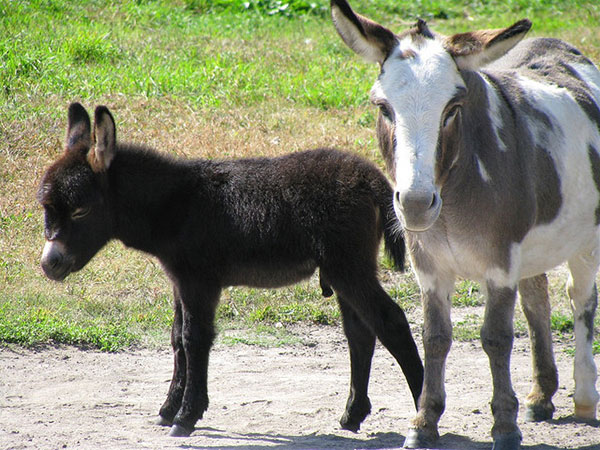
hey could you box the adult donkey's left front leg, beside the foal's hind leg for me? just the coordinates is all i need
[404,271,454,448]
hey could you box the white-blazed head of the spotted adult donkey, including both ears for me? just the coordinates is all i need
[332,2,530,231]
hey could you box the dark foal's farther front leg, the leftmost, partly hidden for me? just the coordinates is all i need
[156,287,186,427]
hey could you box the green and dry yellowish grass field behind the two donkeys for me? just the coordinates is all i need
[0,0,600,351]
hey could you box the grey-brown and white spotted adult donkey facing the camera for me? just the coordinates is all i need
[331,0,600,449]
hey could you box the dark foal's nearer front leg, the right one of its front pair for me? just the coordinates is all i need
[170,282,220,436]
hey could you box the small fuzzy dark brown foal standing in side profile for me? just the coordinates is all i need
[38,103,423,436]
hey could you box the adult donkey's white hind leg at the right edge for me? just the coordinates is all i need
[567,248,600,419]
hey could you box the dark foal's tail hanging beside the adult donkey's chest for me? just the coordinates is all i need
[379,180,406,271]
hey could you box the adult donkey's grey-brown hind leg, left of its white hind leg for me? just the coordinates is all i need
[519,274,558,422]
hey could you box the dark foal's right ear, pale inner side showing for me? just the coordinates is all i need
[88,106,117,172]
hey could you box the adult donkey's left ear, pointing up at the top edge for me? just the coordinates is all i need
[331,0,397,64]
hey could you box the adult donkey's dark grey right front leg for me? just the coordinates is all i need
[481,282,521,450]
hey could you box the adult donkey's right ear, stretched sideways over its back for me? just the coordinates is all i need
[444,19,531,70]
